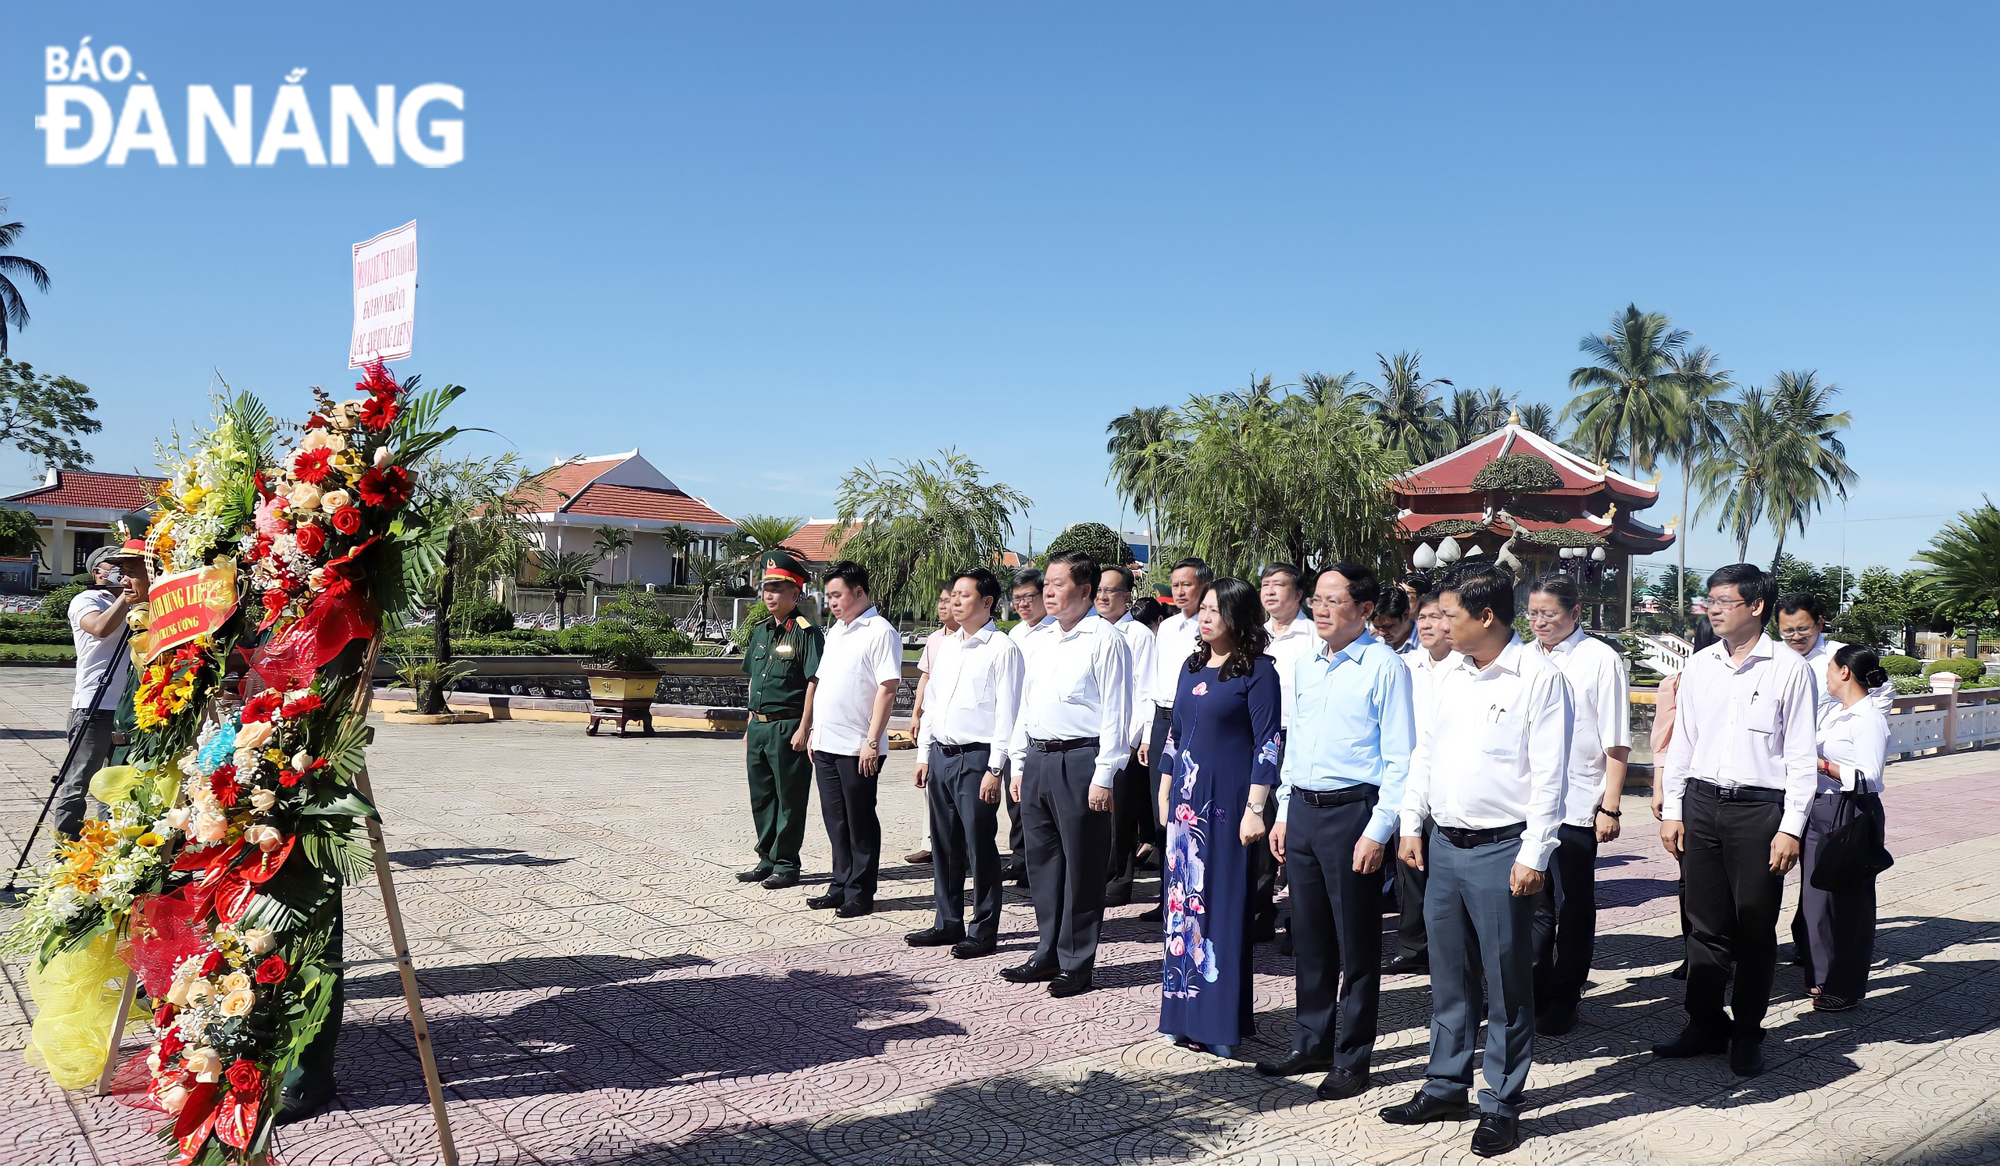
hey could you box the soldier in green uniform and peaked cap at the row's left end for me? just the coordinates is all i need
[736,550,826,890]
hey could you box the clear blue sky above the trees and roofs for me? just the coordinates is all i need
[0,2,2000,568]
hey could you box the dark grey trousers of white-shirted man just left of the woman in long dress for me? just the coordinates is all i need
[1020,746,1112,972]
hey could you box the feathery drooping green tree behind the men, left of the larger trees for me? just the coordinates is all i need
[840,450,1030,614]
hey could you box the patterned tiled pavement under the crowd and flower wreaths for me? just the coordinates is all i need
[0,670,2000,1166]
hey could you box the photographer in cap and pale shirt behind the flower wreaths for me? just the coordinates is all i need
[56,546,148,840]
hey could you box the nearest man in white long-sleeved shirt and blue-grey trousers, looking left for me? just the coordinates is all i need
[1382,564,1572,1158]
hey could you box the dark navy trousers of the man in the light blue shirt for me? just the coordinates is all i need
[1284,790,1394,1072]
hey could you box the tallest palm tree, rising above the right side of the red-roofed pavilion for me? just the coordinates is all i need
[1562,304,1688,476]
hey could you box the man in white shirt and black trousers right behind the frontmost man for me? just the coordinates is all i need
[1528,576,1632,1036]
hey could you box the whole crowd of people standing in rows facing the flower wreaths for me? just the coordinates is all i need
[738,552,1888,1156]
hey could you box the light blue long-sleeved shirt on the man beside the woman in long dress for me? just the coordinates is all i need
[1278,632,1416,844]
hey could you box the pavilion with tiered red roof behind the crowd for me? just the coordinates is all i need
[1390,418,1674,620]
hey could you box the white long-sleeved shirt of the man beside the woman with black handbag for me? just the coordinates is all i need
[1660,634,1820,838]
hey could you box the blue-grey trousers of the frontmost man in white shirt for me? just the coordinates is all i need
[1424,834,1534,1118]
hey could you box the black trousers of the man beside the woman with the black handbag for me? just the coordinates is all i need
[1682,782,1784,1036]
